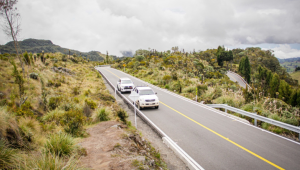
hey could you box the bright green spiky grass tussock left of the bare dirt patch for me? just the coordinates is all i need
[44,133,75,157]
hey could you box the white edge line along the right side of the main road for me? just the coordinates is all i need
[111,68,300,145]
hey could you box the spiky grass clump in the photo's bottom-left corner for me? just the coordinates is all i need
[0,139,17,169]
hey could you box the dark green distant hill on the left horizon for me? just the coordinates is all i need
[0,39,111,61]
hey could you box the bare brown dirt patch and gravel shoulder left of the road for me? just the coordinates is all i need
[79,77,188,170]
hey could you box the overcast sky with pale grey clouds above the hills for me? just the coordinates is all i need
[0,0,300,58]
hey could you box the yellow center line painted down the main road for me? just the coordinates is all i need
[100,69,284,170]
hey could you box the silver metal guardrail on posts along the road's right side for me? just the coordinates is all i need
[207,104,300,140]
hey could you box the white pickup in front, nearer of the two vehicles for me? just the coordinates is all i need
[131,87,159,110]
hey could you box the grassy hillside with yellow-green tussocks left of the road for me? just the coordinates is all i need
[0,53,164,170]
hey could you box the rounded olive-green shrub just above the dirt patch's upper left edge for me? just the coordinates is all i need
[60,109,86,136]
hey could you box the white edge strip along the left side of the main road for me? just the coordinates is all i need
[95,66,204,170]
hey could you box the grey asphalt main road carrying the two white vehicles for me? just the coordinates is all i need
[97,67,300,170]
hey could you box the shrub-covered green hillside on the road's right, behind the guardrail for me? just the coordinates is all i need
[113,46,300,139]
